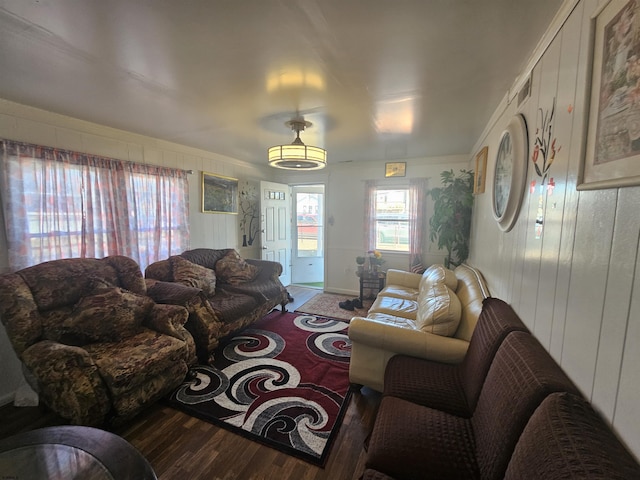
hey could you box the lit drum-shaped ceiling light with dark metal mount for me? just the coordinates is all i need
[268,118,327,170]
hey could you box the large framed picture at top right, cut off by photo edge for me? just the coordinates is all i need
[578,0,640,190]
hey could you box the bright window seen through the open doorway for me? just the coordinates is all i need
[296,193,324,257]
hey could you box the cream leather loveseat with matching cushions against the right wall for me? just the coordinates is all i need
[349,265,489,392]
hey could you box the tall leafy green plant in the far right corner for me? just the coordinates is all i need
[429,170,473,268]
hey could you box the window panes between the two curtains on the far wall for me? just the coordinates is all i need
[373,188,411,252]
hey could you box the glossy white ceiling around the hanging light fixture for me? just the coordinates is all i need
[0,0,562,163]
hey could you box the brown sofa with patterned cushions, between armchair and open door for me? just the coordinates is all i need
[145,248,289,363]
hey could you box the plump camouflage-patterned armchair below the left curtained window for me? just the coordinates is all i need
[0,256,195,426]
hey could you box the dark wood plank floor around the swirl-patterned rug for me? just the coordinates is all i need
[0,287,380,480]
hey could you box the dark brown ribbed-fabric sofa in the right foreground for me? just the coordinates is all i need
[362,298,640,480]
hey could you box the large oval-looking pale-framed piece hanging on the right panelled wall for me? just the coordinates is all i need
[493,114,529,232]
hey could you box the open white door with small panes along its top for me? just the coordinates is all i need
[260,182,291,286]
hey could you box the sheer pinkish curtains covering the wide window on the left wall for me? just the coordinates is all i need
[0,140,189,270]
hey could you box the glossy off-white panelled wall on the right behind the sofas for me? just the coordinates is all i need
[470,0,640,457]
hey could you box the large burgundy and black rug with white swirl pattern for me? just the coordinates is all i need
[169,310,351,466]
